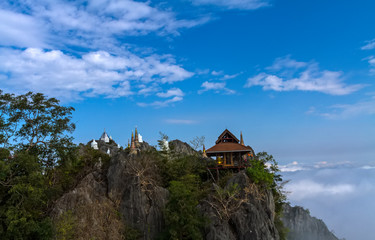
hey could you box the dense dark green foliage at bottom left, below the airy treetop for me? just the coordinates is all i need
[0,149,52,239]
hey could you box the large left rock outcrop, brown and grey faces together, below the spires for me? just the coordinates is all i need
[51,141,168,239]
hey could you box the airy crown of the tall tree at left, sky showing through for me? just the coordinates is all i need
[0,90,75,168]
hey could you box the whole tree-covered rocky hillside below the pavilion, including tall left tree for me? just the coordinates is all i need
[0,92,334,240]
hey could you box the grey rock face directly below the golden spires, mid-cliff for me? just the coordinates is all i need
[107,150,168,239]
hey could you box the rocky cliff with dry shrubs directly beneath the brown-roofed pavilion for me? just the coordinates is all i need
[202,171,279,240]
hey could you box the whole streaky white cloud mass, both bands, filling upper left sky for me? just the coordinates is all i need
[0,0,209,106]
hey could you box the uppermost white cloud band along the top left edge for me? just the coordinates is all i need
[0,0,209,49]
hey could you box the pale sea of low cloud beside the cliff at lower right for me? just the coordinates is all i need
[282,162,375,240]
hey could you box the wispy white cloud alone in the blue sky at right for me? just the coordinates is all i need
[245,56,363,95]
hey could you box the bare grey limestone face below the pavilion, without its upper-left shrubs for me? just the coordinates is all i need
[201,172,279,240]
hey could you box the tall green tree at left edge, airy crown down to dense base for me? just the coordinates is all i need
[0,91,76,239]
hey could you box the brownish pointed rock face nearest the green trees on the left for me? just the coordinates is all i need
[51,169,123,240]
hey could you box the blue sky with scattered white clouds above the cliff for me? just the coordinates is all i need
[0,0,375,239]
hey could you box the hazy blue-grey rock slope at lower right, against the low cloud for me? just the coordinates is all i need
[282,204,338,240]
